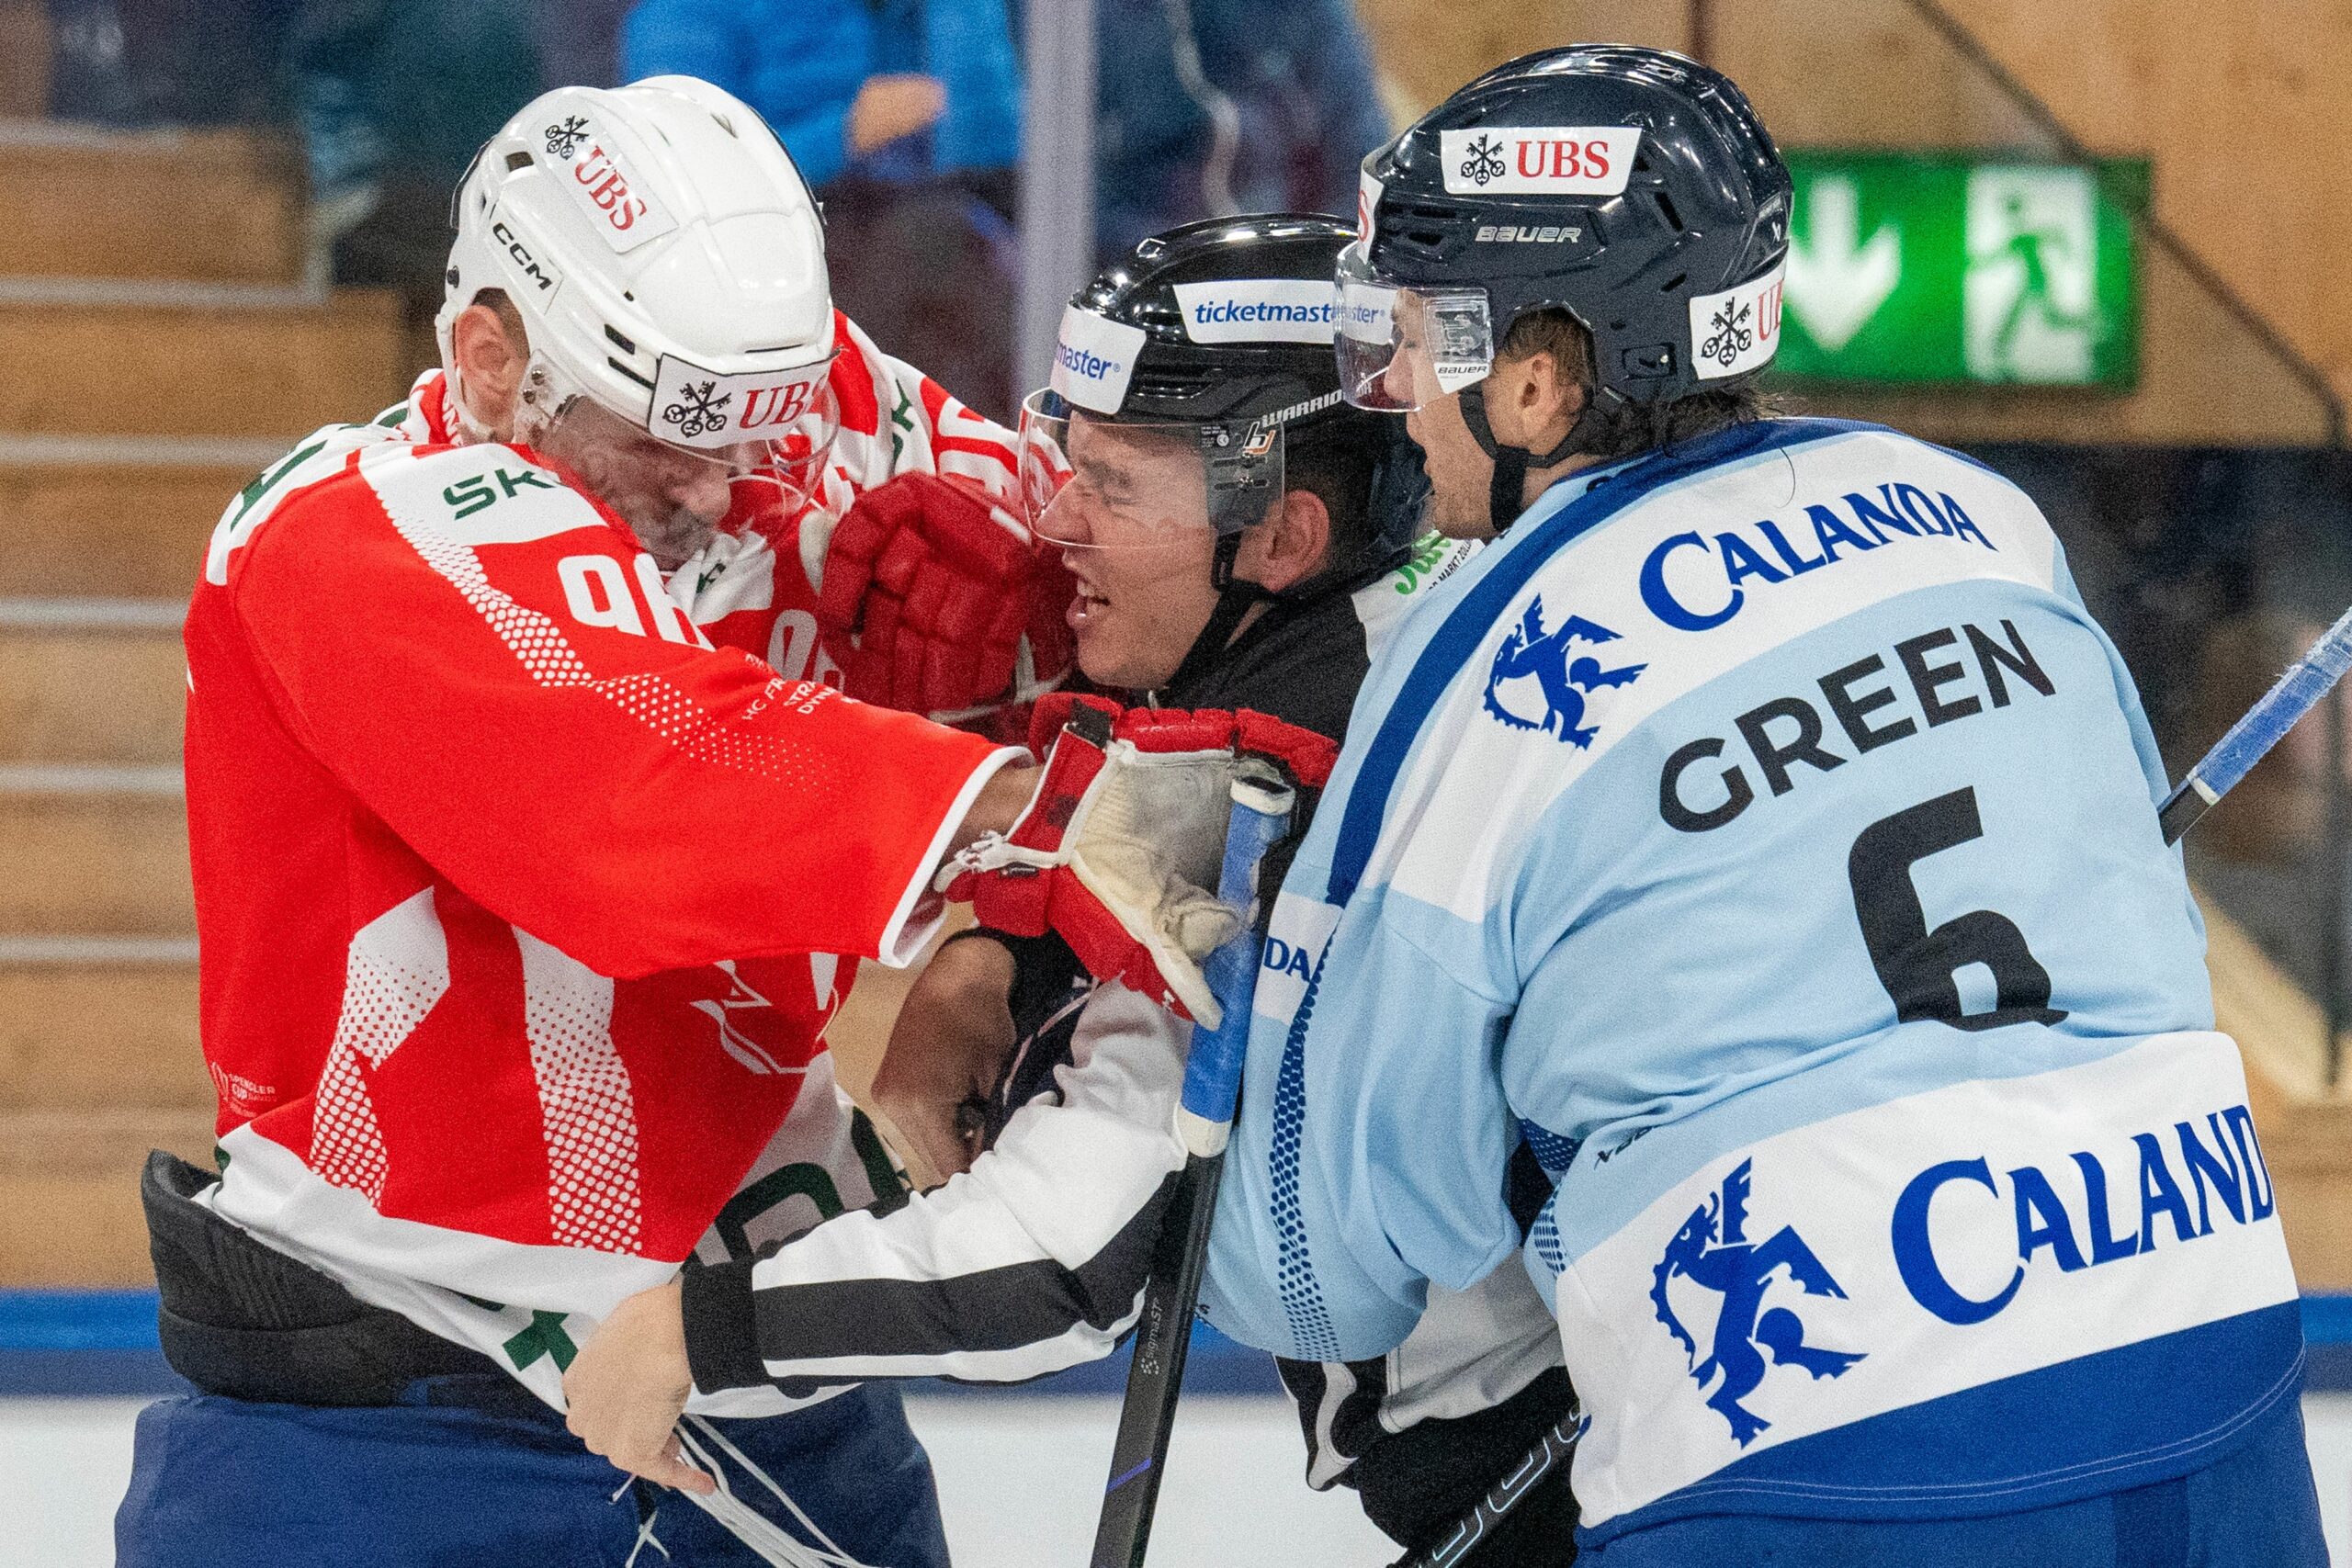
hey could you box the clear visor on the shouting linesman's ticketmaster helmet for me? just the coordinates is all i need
[1021,392,1284,550]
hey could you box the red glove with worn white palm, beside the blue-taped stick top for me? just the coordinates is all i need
[944,694,1339,1027]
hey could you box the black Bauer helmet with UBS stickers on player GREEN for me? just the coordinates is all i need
[1339,45,1790,526]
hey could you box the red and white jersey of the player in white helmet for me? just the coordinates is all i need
[186,322,1018,1413]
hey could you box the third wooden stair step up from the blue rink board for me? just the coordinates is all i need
[0,764,195,936]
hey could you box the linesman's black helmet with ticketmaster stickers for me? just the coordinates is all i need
[1021,214,1428,576]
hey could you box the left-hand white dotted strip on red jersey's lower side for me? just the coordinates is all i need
[311,888,449,1201]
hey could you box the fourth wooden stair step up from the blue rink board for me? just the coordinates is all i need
[0,600,188,766]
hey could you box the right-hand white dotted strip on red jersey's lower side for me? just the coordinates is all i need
[515,929,642,1253]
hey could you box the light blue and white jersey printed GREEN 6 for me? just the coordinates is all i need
[1204,421,2302,1538]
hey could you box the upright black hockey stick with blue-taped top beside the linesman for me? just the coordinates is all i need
[1091,773,1291,1568]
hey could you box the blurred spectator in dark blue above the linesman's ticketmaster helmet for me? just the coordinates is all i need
[1093,0,1387,256]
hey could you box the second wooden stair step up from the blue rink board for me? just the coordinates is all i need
[0,938,198,1114]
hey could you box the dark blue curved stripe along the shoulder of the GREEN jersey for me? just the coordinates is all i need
[1324,419,1882,905]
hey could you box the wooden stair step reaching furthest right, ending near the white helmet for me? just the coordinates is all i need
[0,291,407,446]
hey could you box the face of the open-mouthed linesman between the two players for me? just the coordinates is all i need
[1037,419,1216,691]
